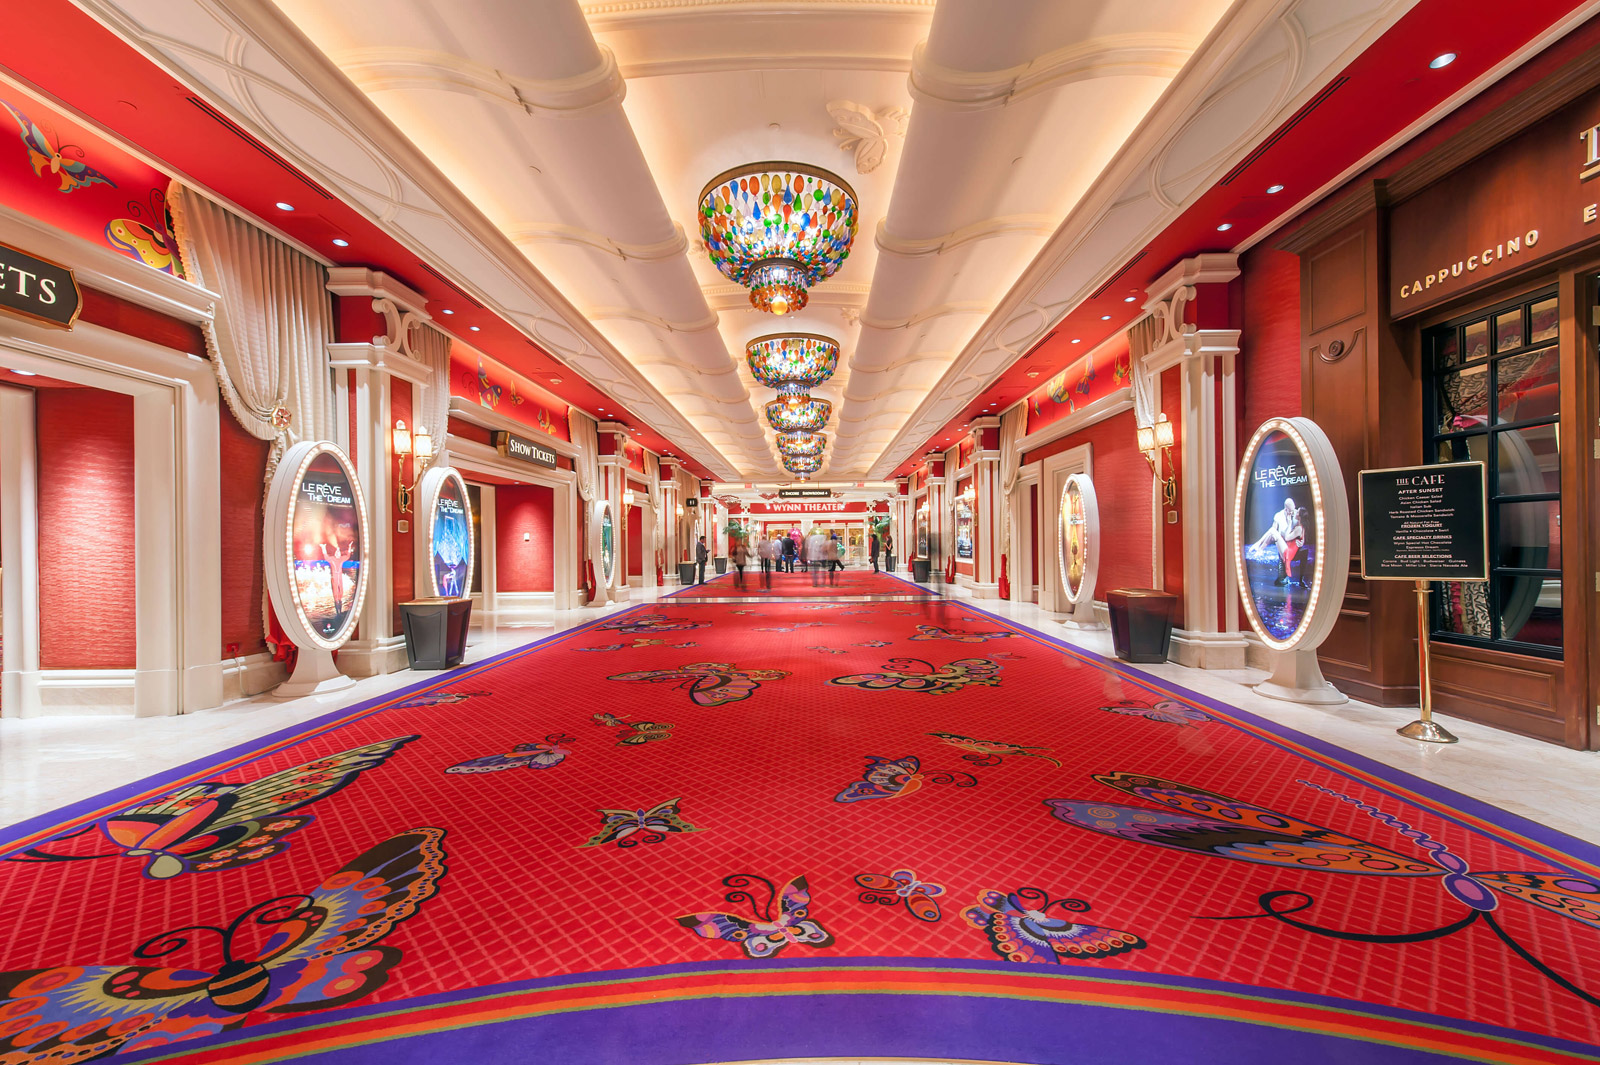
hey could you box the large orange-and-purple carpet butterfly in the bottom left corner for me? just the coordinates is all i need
[0,828,445,1065]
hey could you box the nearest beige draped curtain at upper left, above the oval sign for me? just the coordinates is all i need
[166,182,334,481]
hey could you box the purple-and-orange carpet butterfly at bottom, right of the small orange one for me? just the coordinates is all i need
[962,888,1146,964]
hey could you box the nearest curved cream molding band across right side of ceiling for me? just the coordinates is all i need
[910,34,1200,110]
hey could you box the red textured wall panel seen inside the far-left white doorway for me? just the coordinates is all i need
[34,389,136,670]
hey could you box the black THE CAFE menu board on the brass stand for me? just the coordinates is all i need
[1362,462,1490,580]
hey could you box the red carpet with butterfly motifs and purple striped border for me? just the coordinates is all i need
[0,591,1600,1065]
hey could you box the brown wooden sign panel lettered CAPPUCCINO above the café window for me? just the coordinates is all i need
[1389,83,1600,318]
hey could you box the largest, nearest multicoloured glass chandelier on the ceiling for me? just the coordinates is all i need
[699,163,858,315]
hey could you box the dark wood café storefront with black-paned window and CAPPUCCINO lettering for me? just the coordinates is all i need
[1277,56,1600,748]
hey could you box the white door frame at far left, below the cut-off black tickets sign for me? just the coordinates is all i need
[0,320,222,716]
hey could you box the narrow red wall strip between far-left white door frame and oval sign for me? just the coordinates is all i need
[218,403,272,656]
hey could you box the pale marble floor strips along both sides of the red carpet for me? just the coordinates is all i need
[0,575,1600,843]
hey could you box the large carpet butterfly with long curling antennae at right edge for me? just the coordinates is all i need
[1045,772,1600,1006]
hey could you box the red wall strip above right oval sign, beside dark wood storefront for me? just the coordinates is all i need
[1238,248,1301,454]
